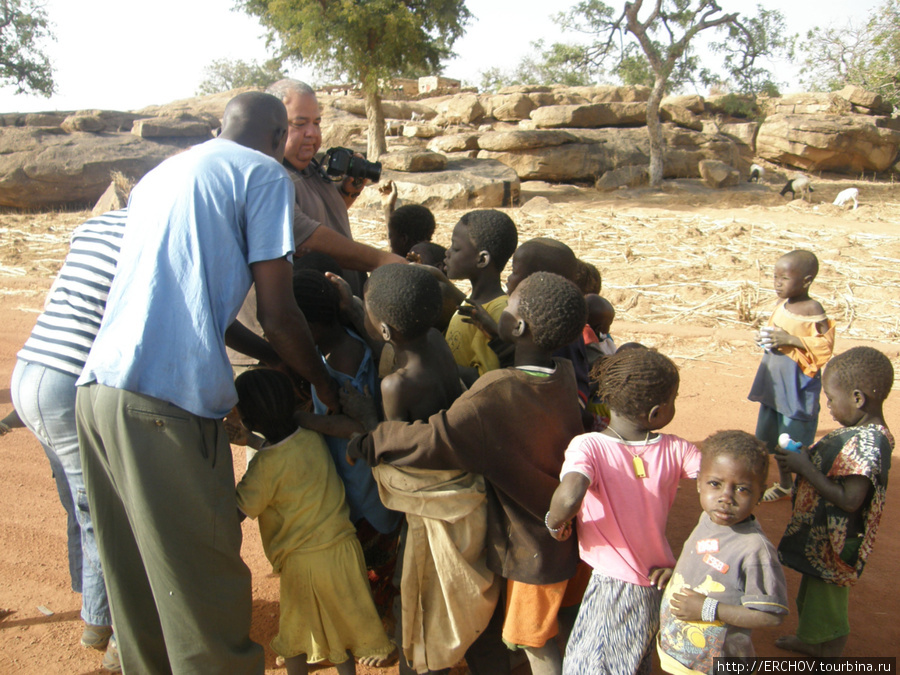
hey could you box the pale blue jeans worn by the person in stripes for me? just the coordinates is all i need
[10,360,112,626]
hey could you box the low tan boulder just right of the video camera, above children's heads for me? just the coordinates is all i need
[358,158,520,209]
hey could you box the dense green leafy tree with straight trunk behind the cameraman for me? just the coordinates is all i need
[240,0,471,160]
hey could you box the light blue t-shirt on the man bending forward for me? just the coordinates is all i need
[78,138,294,418]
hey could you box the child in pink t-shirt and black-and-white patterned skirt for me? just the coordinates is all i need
[545,348,700,675]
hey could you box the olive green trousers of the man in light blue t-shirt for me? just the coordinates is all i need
[76,384,264,675]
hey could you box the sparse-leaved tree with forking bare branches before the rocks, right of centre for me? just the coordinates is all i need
[536,0,789,185]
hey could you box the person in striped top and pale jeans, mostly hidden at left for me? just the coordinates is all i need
[10,209,127,667]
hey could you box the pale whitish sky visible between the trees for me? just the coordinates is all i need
[0,0,883,112]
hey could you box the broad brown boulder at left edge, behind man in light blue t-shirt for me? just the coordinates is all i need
[0,127,209,209]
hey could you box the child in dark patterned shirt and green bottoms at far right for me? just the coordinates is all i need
[775,347,894,657]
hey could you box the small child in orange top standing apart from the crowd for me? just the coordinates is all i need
[747,250,834,502]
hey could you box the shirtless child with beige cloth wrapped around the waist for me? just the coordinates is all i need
[365,265,500,673]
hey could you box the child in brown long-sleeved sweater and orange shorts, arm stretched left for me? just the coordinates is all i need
[348,273,585,675]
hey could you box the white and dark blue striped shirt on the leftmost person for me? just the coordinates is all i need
[18,209,128,376]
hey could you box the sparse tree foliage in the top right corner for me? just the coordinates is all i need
[798,0,900,106]
